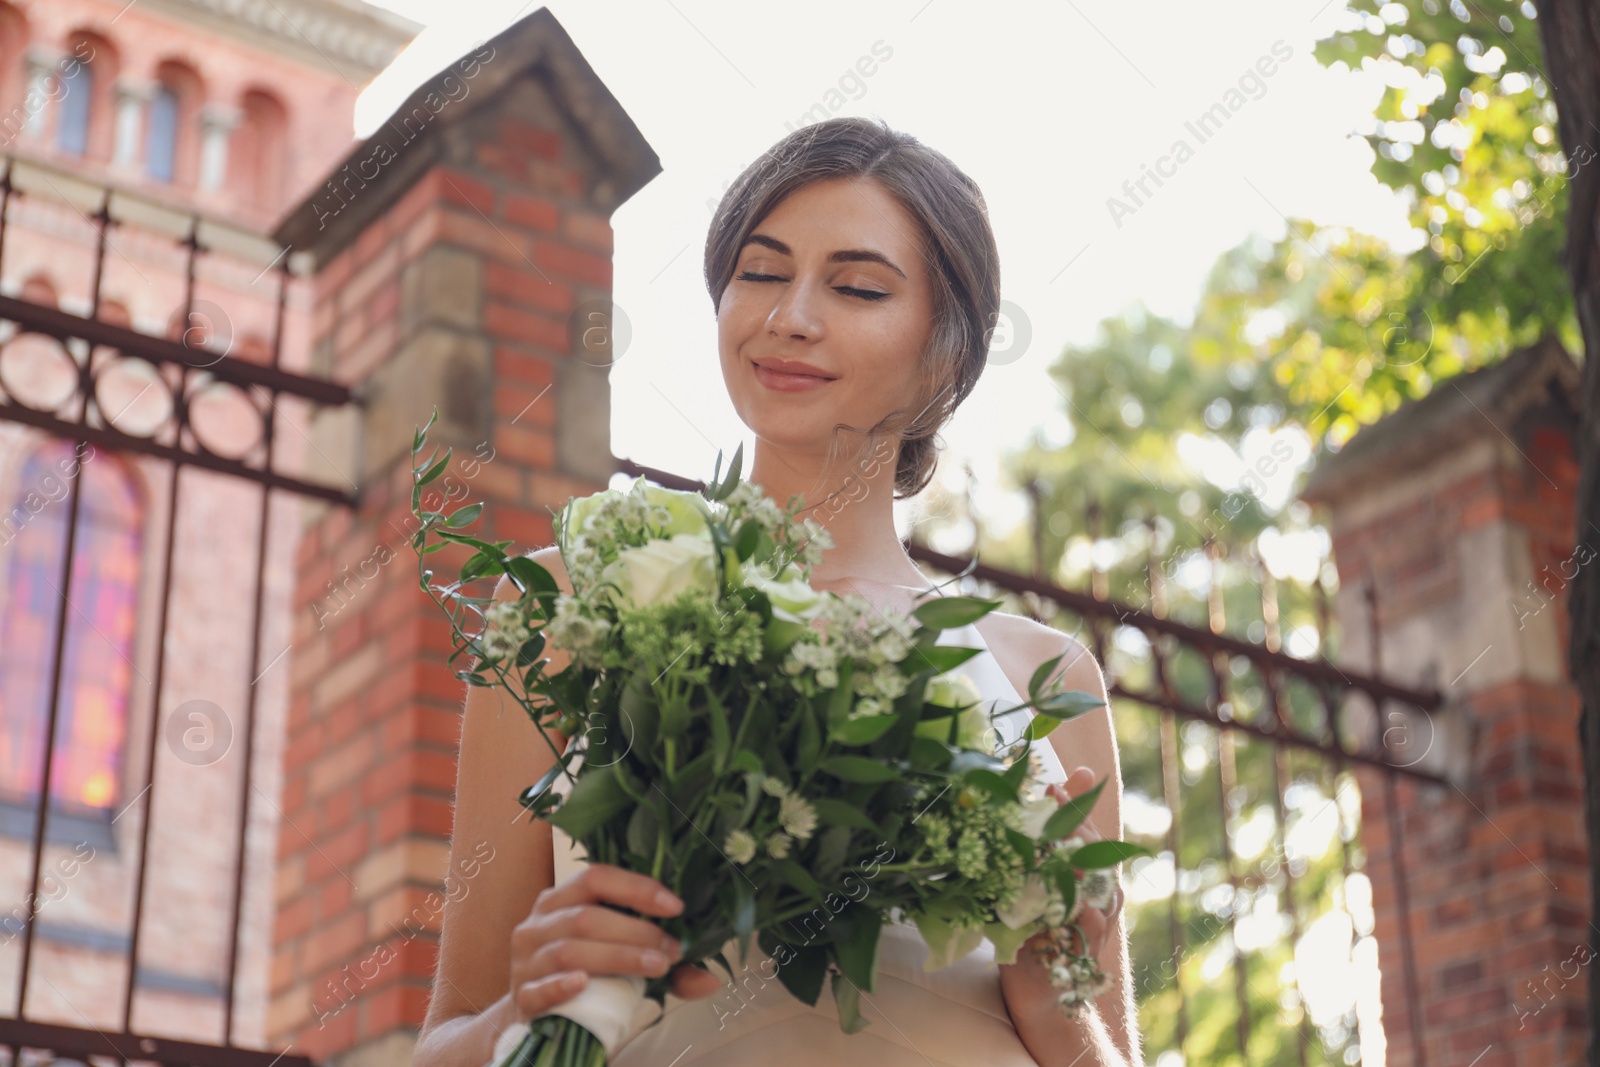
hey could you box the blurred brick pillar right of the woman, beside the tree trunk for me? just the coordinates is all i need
[1306,341,1600,1067]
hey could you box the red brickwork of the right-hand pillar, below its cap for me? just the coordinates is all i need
[1334,426,1600,1067]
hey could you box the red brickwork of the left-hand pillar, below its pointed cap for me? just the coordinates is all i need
[269,108,611,1059]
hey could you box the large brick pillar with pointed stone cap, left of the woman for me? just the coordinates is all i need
[267,11,659,1064]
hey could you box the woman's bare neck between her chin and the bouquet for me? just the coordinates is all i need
[749,438,928,589]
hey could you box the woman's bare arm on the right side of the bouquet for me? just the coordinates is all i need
[998,616,1144,1067]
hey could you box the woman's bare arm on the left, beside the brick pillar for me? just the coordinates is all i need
[413,547,570,1067]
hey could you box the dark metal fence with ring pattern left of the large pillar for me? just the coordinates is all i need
[0,160,355,1067]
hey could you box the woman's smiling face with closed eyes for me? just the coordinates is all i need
[717,178,933,456]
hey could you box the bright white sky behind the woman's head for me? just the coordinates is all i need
[355,0,1405,550]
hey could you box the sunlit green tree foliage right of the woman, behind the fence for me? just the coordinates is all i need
[986,0,1574,1067]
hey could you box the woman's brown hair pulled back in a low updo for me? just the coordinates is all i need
[706,117,1000,499]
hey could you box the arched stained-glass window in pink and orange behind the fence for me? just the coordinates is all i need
[0,440,144,814]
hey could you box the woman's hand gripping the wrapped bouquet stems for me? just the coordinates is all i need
[510,864,722,1019]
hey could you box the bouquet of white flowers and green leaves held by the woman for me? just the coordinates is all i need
[411,413,1147,1067]
